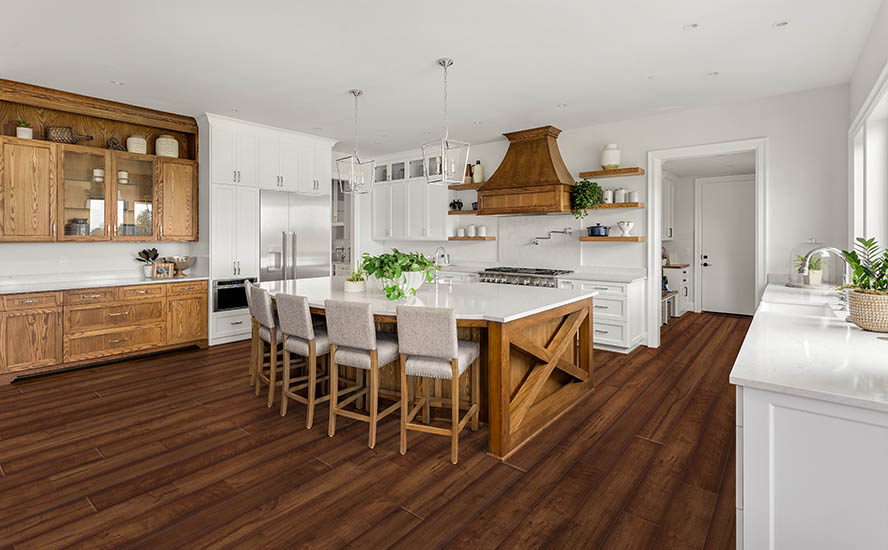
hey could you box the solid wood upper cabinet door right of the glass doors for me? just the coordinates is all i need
[160,160,197,241]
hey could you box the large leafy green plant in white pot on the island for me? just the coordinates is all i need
[361,248,438,300]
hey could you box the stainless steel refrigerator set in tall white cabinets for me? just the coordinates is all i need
[259,191,330,281]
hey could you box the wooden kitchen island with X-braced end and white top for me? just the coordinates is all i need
[259,277,597,459]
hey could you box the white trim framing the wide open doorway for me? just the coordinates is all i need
[646,137,768,348]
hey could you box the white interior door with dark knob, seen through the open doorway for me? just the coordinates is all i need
[698,178,756,315]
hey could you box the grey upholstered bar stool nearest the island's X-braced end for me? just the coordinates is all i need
[397,306,481,464]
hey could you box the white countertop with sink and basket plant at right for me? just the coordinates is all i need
[731,285,888,412]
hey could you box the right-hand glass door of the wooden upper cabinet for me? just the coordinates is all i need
[114,154,155,240]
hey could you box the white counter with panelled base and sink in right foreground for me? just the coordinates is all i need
[730,285,888,550]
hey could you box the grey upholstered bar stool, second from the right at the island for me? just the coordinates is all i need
[324,300,401,449]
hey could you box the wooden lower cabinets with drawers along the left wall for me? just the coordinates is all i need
[0,281,207,379]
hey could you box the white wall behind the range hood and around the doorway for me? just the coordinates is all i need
[359,85,849,278]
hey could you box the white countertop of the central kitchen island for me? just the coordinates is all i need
[259,277,598,323]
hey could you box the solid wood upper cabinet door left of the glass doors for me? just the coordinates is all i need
[0,138,57,241]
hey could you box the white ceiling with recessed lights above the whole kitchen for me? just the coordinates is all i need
[0,0,880,154]
